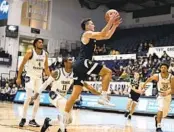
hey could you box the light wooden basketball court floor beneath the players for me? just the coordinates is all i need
[0,102,174,132]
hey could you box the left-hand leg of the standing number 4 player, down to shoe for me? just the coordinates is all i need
[19,76,34,127]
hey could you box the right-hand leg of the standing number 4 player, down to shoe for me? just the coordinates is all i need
[29,78,43,127]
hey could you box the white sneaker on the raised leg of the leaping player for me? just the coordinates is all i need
[98,95,115,107]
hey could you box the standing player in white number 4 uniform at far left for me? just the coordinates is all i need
[16,38,50,127]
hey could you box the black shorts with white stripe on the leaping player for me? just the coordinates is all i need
[73,59,103,86]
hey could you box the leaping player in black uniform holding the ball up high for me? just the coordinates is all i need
[60,13,121,129]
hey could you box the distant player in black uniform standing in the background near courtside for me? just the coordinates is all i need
[125,72,144,120]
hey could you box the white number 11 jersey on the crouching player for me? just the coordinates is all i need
[51,68,73,96]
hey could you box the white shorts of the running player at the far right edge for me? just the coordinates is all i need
[157,95,172,117]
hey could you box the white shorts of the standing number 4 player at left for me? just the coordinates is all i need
[25,75,43,98]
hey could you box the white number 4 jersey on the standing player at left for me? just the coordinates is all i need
[25,49,46,78]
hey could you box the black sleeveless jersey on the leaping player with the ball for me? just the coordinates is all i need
[79,36,96,60]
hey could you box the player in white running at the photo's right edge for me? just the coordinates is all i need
[143,63,174,132]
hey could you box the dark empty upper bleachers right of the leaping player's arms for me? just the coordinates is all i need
[108,24,174,53]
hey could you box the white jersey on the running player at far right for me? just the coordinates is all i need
[157,73,172,92]
